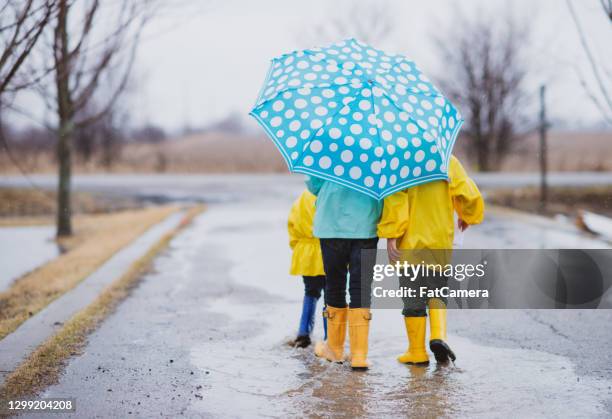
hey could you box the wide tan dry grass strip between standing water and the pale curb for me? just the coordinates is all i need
[0,206,177,339]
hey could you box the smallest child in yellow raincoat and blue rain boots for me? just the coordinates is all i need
[287,191,327,348]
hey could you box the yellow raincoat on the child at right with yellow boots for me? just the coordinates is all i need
[377,156,484,260]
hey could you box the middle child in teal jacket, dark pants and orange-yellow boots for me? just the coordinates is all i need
[306,177,382,370]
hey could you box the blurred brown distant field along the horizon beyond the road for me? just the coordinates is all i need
[0,132,612,173]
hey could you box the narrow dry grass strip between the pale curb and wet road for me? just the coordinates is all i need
[0,207,202,400]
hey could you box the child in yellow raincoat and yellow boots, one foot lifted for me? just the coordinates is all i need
[377,156,484,365]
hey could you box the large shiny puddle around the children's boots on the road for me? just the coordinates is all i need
[190,208,611,417]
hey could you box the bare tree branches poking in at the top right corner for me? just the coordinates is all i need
[565,0,612,125]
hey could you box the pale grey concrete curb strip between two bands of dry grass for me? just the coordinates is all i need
[0,211,184,385]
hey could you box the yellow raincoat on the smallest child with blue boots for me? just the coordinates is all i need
[287,190,325,276]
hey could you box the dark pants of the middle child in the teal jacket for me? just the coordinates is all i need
[321,237,378,308]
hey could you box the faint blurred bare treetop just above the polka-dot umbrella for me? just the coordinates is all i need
[297,0,395,46]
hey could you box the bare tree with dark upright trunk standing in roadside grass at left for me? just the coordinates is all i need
[41,0,152,236]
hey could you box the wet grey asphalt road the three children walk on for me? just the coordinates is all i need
[15,178,612,417]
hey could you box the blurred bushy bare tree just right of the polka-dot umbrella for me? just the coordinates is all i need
[436,11,529,171]
